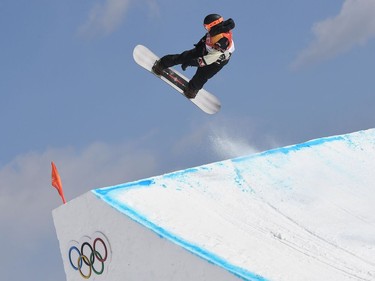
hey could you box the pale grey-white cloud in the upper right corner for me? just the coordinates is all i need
[292,0,375,68]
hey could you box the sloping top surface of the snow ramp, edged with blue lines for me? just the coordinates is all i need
[93,129,375,281]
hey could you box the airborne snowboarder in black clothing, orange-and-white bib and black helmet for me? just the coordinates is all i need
[152,14,235,99]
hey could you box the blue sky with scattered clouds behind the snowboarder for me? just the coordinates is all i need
[0,0,375,281]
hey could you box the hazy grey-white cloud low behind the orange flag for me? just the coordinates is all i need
[0,142,157,240]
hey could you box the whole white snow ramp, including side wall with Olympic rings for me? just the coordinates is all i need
[53,129,375,281]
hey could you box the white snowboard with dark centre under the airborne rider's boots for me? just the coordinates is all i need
[133,45,221,114]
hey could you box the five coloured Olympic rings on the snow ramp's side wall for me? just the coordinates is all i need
[68,232,111,279]
